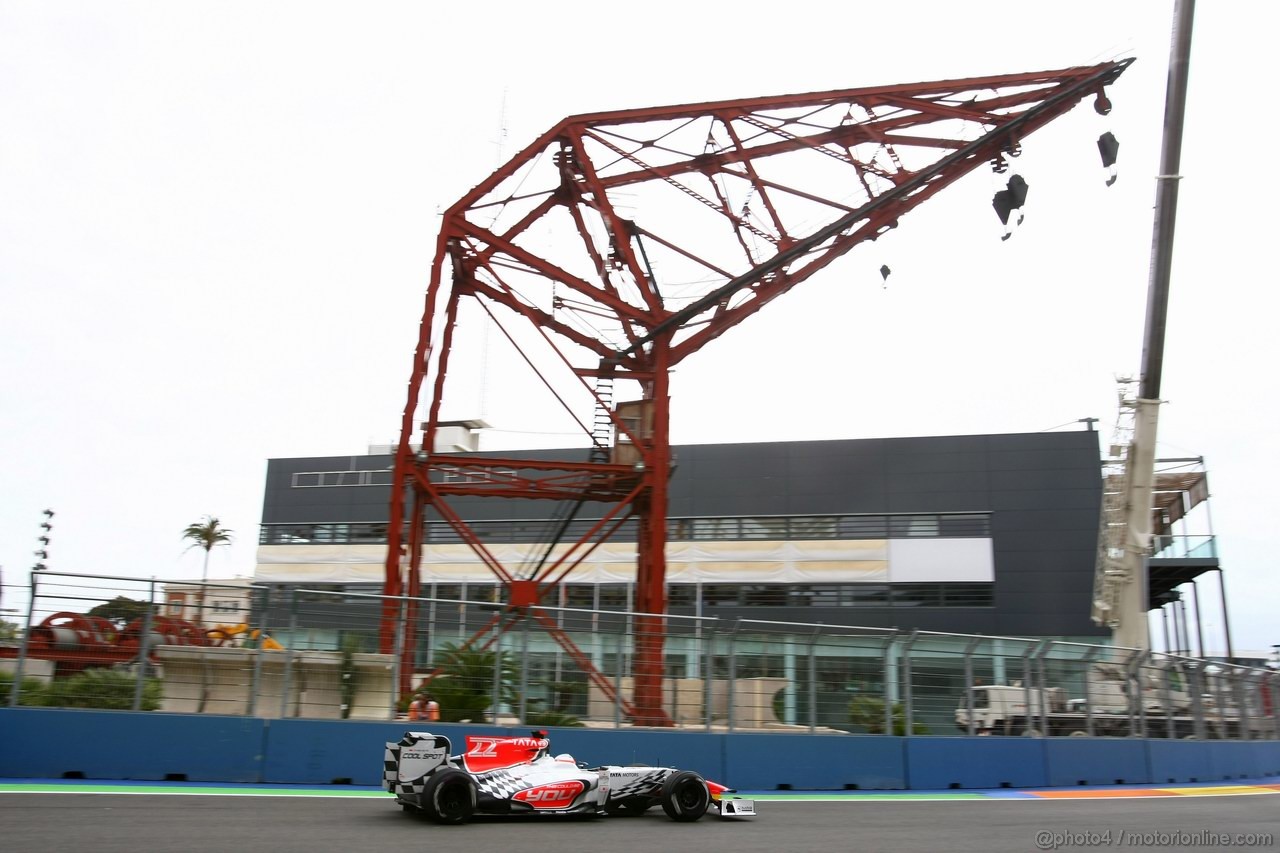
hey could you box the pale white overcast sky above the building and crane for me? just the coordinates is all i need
[0,0,1280,649]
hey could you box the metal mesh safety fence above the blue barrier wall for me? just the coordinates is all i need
[0,571,1280,740]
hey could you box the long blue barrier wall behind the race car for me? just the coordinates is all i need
[0,708,1280,790]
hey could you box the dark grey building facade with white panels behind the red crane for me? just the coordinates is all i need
[257,430,1107,639]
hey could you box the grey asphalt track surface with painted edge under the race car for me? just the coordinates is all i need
[0,780,1280,853]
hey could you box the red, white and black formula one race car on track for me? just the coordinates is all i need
[383,731,755,824]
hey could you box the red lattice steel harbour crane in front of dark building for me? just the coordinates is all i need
[380,60,1132,725]
